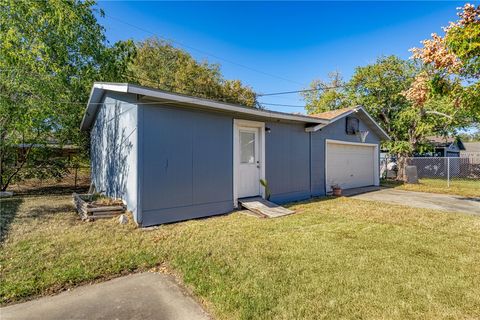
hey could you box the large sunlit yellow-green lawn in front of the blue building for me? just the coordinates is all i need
[0,195,480,319]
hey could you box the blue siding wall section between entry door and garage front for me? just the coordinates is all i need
[265,122,310,203]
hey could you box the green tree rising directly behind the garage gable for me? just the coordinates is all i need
[304,56,417,152]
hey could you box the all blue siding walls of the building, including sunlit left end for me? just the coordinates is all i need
[91,93,380,226]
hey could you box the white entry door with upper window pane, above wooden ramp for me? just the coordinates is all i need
[236,127,261,198]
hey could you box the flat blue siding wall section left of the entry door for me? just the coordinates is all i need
[139,105,233,226]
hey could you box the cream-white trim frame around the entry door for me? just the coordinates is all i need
[233,119,265,208]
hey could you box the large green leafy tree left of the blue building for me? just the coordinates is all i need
[0,0,134,190]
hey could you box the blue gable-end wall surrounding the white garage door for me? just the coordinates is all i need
[311,118,380,196]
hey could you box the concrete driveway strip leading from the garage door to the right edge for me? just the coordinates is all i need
[350,188,480,215]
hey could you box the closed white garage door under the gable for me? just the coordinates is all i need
[325,141,378,192]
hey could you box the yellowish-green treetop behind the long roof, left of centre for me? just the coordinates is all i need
[129,37,256,107]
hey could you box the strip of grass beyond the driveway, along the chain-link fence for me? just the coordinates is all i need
[382,178,480,198]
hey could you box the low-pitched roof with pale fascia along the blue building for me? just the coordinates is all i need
[80,82,390,140]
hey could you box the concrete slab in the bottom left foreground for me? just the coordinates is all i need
[0,273,210,320]
